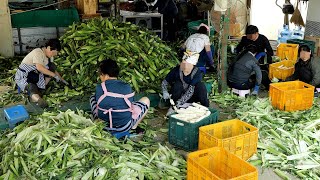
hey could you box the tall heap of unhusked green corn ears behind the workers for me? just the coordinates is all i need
[55,19,178,93]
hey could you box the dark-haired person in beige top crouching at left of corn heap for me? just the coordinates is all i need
[15,39,68,108]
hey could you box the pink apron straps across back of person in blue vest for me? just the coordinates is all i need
[96,82,135,131]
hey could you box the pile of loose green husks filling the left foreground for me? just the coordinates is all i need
[0,110,186,180]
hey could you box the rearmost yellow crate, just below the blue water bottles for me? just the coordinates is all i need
[277,43,299,61]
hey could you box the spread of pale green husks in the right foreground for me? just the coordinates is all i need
[211,93,320,179]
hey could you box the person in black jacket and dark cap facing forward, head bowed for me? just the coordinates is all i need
[235,25,273,64]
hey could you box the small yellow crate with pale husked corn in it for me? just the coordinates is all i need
[269,60,296,80]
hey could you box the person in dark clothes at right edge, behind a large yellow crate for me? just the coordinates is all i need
[285,45,320,88]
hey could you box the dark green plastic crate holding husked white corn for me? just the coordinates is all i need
[169,108,219,151]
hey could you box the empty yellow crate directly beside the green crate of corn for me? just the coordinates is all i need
[199,119,258,160]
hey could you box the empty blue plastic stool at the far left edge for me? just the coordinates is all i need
[3,105,30,128]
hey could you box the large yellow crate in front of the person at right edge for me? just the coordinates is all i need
[269,81,314,111]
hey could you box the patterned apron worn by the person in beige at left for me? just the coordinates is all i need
[15,63,48,91]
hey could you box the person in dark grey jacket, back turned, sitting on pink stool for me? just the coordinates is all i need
[228,45,262,95]
